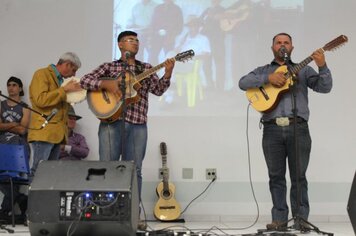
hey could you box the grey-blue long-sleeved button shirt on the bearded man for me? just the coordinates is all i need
[239,60,332,121]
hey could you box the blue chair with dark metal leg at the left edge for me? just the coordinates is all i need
[0,144,30,227]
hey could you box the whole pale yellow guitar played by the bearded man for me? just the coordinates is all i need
[246,35,348,112]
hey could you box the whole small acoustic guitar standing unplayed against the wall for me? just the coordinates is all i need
[153,142,181,221]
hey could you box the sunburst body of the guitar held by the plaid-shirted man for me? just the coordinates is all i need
[87,72,140,123]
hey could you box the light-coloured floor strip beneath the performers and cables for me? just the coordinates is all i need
[0,222,355,236]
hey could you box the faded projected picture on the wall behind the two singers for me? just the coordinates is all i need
[113,0,303,116]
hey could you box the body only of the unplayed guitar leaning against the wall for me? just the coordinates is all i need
[153,182,181,221]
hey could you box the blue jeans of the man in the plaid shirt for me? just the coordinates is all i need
[99,120,147,200]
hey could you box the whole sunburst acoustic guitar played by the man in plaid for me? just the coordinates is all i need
[87,50,194,122]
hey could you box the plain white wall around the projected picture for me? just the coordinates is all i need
[0,0,356,221]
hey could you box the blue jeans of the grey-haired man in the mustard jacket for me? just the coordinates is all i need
[30,141,61,175]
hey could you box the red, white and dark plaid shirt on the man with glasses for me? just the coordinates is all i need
[80,60,170,124]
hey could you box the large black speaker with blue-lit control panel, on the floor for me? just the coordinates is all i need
[28,160,139,236]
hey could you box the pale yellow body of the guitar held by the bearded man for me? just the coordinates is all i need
[246,65,292,112]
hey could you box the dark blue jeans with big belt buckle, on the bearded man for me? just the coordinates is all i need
[262,122,311,222]
